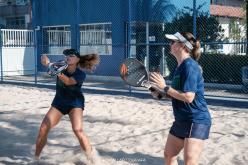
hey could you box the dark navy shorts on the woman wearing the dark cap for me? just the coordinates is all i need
[51,97,84,115]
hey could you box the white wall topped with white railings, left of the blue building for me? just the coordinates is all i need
[0,29,35,76]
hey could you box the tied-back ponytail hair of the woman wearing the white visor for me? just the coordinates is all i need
[181,32,201,61]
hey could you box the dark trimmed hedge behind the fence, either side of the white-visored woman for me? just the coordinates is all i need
[166,54,248,84]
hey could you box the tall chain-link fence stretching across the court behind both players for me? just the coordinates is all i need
[0,0,248,95]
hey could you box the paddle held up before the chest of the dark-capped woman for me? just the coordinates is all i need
[47,61,68,76]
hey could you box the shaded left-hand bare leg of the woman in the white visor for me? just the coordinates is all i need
[164,134,184,165]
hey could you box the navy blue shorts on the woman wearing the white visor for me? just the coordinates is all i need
[170,121,211,140]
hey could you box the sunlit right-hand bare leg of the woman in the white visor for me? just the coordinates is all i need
[184,138,204,165]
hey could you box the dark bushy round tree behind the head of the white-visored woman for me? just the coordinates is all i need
[164,10,224,79]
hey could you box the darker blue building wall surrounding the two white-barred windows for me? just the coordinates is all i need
[33,0,134,76]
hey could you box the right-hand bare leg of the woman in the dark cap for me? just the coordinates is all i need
[69,108,92,156]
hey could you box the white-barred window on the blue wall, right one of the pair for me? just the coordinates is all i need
[80,23,112,55]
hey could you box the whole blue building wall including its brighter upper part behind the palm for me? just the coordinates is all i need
[32,0,210,76]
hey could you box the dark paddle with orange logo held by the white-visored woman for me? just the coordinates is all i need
[120,58,164,99]
